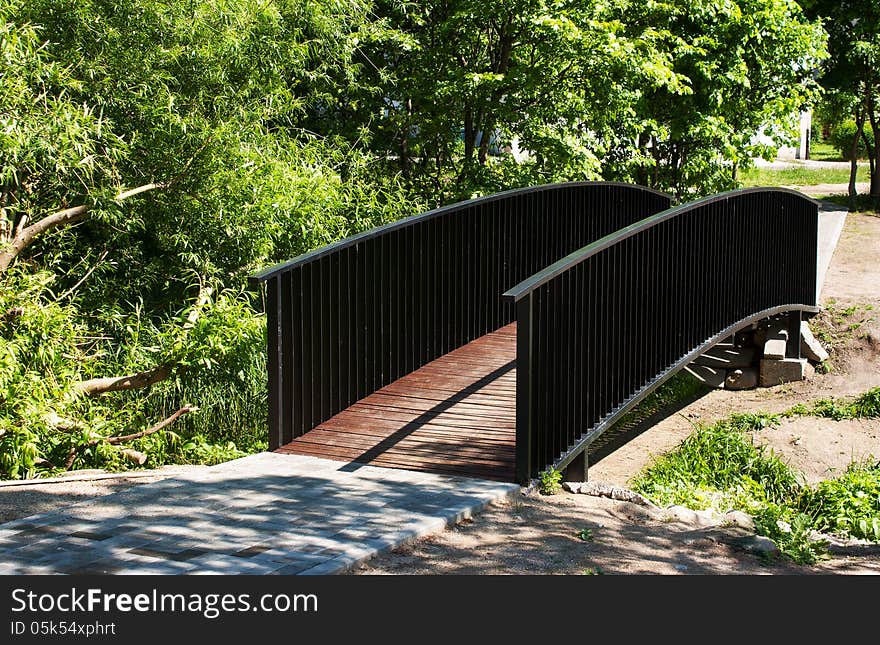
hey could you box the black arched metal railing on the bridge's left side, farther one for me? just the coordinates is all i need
[251,182,670,449]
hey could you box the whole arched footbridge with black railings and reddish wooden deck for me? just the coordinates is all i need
[251,182,818,483]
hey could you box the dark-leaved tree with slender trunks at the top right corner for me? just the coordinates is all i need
[802,0,880,210]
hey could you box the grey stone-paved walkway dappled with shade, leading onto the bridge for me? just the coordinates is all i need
[0,453,520,575]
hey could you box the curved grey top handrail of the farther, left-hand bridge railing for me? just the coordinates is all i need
[249,181,670,285]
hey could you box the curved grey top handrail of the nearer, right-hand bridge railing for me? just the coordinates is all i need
[502,187,819,301]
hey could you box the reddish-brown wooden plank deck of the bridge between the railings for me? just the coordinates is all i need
[277,323,516,481]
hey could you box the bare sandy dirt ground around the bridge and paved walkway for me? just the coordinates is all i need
[0,214,880,575]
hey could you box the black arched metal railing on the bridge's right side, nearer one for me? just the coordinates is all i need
[504,188,818,482]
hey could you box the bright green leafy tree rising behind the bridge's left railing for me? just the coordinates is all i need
[327,0,675,202]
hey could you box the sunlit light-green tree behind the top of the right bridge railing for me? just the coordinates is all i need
[608,0,825,196]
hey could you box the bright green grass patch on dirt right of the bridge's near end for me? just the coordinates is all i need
[631,388,880,564]
